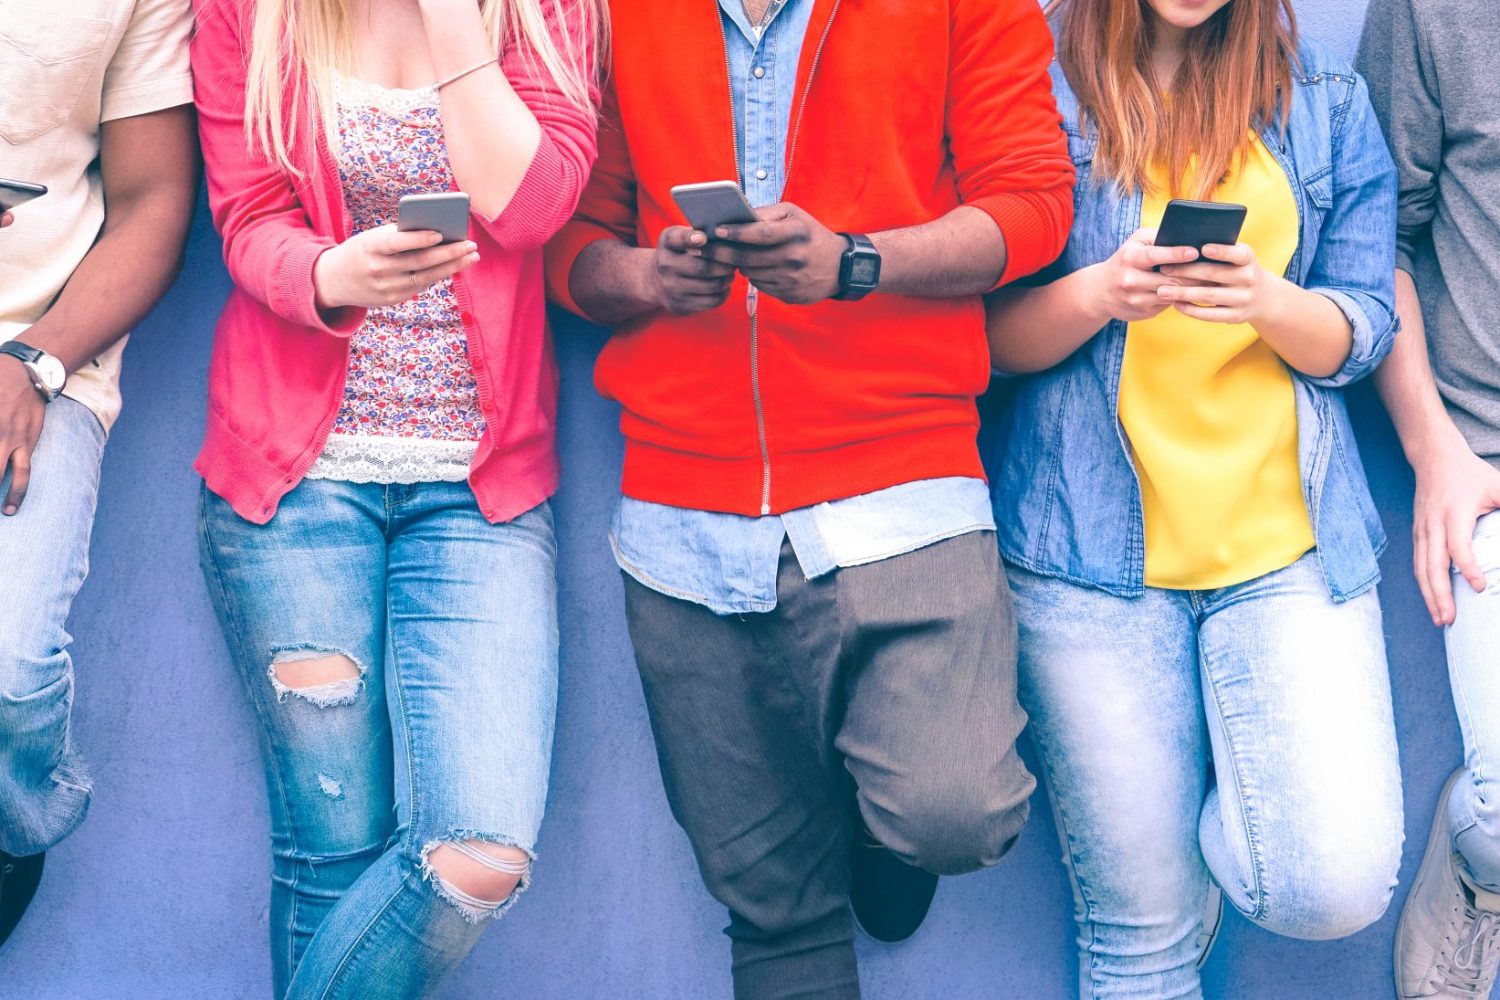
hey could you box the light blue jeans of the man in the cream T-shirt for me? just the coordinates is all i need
[0,396,105,855]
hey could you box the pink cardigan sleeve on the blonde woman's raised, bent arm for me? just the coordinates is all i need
[476,3,599,250]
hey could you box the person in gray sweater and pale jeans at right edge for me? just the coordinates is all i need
[1359,0,1500,1000]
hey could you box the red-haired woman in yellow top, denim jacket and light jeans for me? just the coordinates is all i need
[990,0,1403,997]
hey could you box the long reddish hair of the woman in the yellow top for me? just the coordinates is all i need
[1047,0,1298,198]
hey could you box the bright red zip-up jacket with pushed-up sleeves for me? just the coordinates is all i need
[548,0,1073,516]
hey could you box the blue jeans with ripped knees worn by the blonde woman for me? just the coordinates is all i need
[200,480,558,1000]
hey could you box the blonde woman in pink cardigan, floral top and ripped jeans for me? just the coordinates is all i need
[192,0,603,1000]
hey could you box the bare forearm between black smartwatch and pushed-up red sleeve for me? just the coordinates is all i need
[870,207,1007,298]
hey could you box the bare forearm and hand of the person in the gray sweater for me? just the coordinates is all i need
[1376,270,1500,625]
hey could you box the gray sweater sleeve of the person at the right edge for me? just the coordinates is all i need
[1359,0,1443,274]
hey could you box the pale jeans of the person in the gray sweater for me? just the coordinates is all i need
[1446,511,1500,892]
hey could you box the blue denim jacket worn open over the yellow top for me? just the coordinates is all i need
[990,42,1397,601]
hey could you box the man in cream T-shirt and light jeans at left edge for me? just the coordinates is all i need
[0,0,198,943]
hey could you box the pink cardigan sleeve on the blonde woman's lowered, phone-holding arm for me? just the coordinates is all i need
[192,0,365,336]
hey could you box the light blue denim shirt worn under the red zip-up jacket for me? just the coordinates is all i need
[611,0,995,615]
